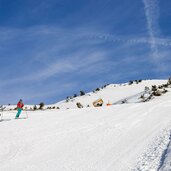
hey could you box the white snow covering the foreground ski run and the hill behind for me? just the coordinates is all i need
[0,80,171,171]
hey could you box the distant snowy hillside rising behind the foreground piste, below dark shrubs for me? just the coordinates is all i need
[55,80,167,109]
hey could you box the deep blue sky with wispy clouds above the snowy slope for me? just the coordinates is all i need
[0,0,171,104]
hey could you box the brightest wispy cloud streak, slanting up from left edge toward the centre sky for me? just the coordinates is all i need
[0,48,107,87]
